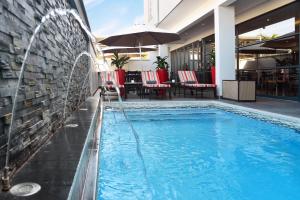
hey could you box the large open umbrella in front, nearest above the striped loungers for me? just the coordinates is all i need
[99,25,180,56]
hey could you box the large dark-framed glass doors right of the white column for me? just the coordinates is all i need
[237,2,300,100]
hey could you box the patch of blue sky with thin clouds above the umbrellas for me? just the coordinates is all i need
[83,0,144,37]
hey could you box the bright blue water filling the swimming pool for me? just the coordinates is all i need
[98,108,300,200]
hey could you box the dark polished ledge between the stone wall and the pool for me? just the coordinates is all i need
[0,94,98,200]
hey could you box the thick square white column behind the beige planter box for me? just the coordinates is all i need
[214,6,235,96]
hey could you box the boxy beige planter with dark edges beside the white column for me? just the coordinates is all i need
[222,80,256,101]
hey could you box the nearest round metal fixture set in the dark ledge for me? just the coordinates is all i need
[10,183,41,197]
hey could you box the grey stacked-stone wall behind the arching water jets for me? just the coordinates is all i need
[0,0,90,171]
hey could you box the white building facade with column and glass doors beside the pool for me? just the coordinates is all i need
[144,0,300,101]
